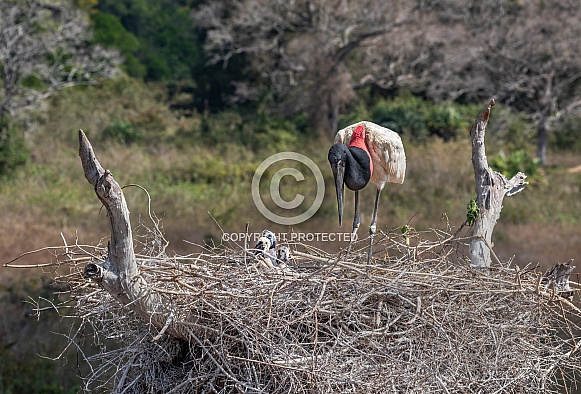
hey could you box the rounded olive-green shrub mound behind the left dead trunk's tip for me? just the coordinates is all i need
[45,77,180,148]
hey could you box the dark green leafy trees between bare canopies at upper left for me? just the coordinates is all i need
[84,0,248,112]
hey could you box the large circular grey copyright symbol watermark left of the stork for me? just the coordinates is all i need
[252,152,325,226]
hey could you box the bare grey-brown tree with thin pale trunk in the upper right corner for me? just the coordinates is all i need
[413,0,581,164]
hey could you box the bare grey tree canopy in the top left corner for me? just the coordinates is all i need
[0,0,120,117]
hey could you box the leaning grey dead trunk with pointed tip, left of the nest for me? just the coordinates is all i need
[79,130,186,339]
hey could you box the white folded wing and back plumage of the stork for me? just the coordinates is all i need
[335,121,406,184]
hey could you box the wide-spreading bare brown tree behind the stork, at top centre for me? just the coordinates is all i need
[194,0,416,134]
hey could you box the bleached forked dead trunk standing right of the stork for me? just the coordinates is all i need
[470,100,528,268]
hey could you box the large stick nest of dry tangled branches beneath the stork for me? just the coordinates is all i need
[15,228,581,393]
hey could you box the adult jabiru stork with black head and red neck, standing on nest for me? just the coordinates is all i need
[328,121,406,263]
